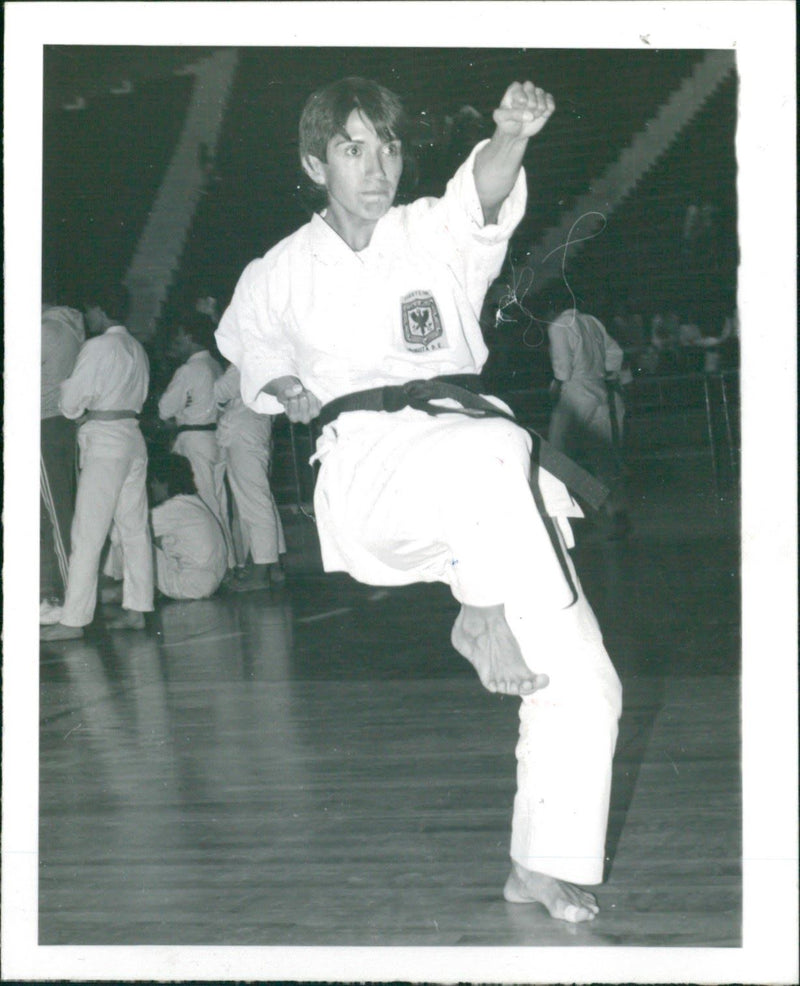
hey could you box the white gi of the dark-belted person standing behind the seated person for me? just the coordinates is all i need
[158,349,234,566]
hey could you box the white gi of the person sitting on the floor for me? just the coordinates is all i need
[150,495,228,599]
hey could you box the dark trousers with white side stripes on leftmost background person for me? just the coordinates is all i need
[39,417,77,599]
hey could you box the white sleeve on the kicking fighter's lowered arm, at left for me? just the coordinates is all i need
[216,254,298,414]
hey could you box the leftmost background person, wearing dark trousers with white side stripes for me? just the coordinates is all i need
[39,292,86,623]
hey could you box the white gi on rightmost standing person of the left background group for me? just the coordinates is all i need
[214,364,286,565]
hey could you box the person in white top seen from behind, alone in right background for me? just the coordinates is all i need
[547,308,629,537]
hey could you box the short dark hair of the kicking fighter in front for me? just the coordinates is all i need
[299,76,407,162]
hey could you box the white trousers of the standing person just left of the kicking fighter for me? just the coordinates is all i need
[222,439,286,565]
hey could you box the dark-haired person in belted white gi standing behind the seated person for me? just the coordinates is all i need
[158,311,235,568]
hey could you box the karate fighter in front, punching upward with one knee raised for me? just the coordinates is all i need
[217,79,621,922]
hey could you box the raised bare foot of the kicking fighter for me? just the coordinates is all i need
[450,606,550,695]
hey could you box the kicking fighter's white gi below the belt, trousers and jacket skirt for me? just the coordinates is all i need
[315,410,622,884]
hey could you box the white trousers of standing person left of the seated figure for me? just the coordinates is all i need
[61,419,153,627]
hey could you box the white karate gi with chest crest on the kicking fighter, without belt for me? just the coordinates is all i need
[217,145,621,884]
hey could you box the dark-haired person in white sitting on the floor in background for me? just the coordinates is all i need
[148,454,228,599]
